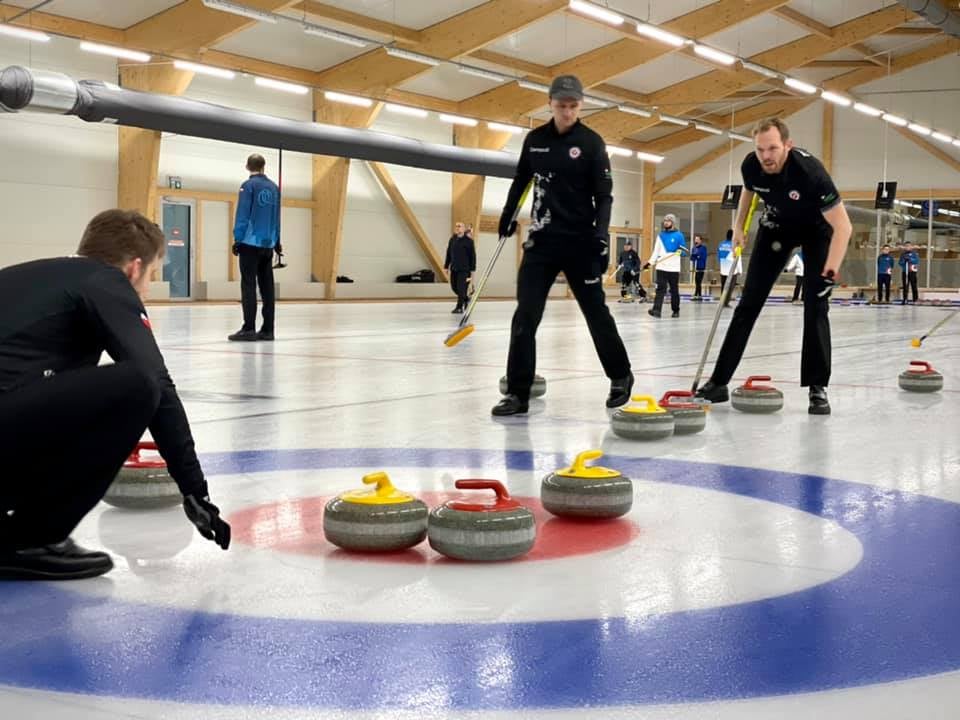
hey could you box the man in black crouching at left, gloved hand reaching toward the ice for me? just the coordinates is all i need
[0,210,230,579]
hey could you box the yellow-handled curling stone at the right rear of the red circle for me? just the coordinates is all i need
[540,450,633,518]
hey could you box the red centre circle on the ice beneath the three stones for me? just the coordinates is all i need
[229,492,640,563]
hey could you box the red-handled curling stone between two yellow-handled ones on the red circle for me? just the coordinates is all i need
[427,480,537,561]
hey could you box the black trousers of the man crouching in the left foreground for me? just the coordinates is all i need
[0,363,160,550]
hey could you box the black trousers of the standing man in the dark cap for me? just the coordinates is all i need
[507,235,630,399]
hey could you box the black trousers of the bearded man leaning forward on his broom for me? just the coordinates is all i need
[710,226,831,387]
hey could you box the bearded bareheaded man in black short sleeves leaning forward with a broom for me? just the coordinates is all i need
[697,118,853,415]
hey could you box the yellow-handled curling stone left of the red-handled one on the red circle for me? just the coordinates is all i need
[323,472,427,552]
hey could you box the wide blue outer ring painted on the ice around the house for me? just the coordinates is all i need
[0,448,960,710]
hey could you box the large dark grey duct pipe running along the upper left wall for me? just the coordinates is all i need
[0,66,517,178]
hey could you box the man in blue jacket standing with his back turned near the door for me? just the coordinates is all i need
[229,155,283,341]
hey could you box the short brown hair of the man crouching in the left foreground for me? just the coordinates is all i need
[77,209,166,268]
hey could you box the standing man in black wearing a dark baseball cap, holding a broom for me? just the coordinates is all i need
[492,75,633,415]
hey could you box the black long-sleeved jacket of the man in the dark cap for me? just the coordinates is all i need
[503,120,613,238]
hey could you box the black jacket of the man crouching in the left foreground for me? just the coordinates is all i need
[0,257,207,495]
